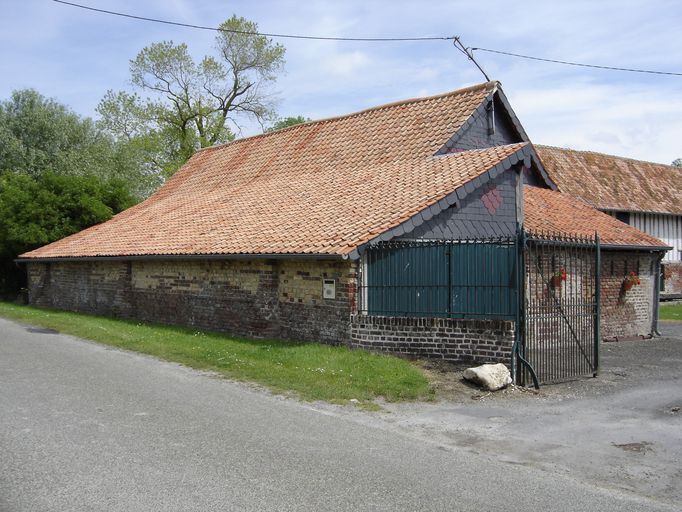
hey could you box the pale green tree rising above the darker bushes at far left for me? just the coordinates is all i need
[0,89,159,197]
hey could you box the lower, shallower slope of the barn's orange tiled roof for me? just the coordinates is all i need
[22,144,525,257]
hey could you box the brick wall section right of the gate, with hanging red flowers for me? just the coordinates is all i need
[601,251,657,340]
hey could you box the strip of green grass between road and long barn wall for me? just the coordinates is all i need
[0,303,434,409]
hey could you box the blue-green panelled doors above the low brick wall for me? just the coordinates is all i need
[366,238,516,320]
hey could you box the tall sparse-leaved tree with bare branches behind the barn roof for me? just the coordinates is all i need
[97,16,285,176]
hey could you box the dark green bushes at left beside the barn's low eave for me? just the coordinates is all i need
[0,172,136,294]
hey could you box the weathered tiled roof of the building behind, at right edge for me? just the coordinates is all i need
[535,145,682,215]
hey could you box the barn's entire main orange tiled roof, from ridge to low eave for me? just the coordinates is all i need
[22,82,525,258]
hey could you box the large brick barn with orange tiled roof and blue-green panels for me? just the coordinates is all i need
[20,82,667,380]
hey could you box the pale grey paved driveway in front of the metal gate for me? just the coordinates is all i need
[364,322,682,510]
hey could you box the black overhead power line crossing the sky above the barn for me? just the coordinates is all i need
[52,0,682,76]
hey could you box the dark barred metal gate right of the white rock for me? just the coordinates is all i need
[516,233,600,385]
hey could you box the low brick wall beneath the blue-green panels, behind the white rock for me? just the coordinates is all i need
[351,315,514,364]
